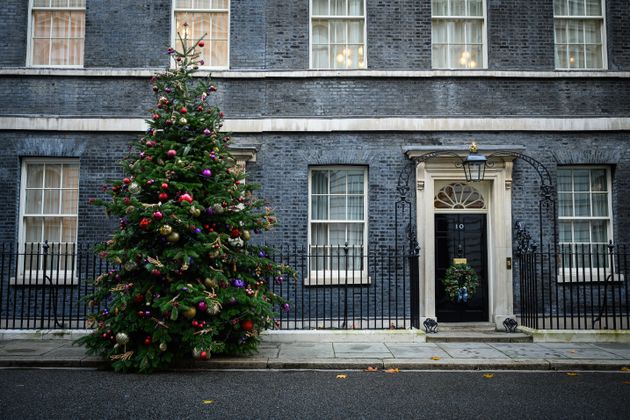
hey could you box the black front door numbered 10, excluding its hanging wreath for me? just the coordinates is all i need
[435,214,488,322]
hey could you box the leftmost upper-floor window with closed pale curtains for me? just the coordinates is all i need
[29,0,85,67]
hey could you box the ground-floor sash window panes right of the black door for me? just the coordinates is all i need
[558,167,612,272]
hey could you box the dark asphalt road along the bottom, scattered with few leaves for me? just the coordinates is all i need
[0,369,630,419]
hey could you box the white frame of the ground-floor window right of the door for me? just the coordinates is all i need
[556,165,623,283]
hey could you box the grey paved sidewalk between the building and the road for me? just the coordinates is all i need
[0,337,630,370]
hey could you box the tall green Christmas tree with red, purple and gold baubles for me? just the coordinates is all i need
[79,36,291,372]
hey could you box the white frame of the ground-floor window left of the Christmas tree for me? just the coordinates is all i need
[15,158,81,286]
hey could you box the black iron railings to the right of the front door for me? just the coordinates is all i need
[517,244,630,330]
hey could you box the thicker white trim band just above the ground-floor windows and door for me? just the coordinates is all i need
[0,116,630,133]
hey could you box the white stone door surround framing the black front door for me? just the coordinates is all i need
[406,147,520,329]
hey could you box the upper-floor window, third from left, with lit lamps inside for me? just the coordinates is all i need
[311,0,367,69]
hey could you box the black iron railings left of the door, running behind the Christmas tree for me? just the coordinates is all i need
[0,243,418,329]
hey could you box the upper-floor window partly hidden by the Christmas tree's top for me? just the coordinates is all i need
[173,0,230,69]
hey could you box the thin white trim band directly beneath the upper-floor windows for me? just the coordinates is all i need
[0,67,630,79]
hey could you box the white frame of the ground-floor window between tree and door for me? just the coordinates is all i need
[304,165,371,286]
